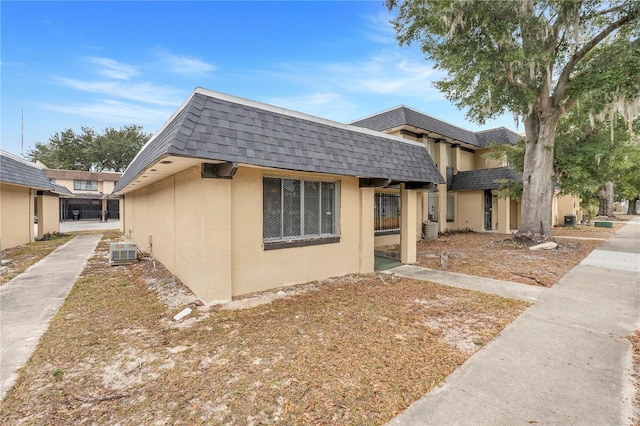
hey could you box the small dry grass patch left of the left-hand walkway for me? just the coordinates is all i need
[0,234,75,285]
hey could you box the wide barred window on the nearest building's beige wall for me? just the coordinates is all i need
[262,176,338,248]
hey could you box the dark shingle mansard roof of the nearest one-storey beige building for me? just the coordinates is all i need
[114,88,444,192]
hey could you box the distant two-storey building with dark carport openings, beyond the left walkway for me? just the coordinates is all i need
[39,163,122,220]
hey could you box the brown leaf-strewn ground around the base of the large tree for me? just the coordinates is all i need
[417,223,624,287]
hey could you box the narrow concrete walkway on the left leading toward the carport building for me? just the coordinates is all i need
[0,234,102,399]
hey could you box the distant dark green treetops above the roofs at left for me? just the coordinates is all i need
[27,126,151,172]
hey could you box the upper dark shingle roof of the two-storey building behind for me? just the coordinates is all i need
[350,105,520,148]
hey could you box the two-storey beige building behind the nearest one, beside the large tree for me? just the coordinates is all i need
[351,106,521,236]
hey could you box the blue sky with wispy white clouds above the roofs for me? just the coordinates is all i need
[0,0,516,155]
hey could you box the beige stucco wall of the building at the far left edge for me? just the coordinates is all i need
[0,183,35,250]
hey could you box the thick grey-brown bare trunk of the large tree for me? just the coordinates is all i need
[518,110,559,240]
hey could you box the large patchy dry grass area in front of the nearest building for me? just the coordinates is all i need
[0,235,526,425]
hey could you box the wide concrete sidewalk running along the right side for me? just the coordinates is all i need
[388,218,640,425]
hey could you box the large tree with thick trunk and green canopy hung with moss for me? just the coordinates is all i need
[387,0,640,238]
